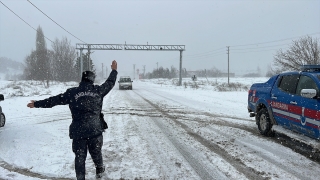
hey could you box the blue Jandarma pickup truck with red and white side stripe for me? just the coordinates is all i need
[248,65,320,139]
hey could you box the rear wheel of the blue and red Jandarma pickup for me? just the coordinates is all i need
[257,108,274,136]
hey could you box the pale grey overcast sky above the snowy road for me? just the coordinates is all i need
[0,0,320,76]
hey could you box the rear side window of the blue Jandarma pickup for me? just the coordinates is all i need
[278,74,299,94]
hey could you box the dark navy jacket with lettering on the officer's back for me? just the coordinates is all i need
[34,70,118,139]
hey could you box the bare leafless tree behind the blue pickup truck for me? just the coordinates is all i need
[273,36,320,73]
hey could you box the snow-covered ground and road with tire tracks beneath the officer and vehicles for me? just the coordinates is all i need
[0,78,320,179]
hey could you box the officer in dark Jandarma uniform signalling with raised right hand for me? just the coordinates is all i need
[27,60,118,180]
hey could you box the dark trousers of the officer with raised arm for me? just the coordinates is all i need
[72,135,103,180]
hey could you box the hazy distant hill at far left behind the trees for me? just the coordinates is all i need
[0,57,24,80]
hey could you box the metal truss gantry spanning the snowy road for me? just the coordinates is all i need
[76,43,185,86]
